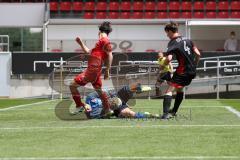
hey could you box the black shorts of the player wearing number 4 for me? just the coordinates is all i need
[171,72,196,88]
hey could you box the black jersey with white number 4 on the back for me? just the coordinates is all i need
[167,36,196,74]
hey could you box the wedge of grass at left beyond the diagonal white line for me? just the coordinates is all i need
[0,99,46,108]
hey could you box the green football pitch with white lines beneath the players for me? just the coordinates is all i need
[0,99,240,160]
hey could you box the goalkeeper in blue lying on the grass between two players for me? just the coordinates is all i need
[79,84,159,119]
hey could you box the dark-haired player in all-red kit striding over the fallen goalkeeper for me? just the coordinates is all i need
[70,22,113,114]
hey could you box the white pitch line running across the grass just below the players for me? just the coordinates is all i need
[0,124,240,130]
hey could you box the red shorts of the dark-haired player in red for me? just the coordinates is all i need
[74,69,102,89]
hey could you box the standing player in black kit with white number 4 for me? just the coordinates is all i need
[161,22,200,119]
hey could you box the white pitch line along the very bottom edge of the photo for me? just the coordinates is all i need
[0,156,240,160]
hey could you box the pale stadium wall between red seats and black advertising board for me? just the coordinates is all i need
[47,24,240,52]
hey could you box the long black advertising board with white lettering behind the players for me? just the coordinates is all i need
[12,52,240,74]
